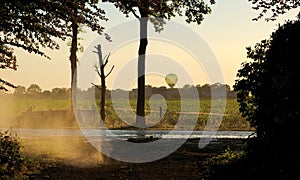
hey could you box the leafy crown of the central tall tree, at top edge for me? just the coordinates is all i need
[102,0,215,28]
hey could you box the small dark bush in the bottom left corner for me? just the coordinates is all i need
[0,129,23,179]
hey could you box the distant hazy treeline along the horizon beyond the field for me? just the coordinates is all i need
[6,83,236,99]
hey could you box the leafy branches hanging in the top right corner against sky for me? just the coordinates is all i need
[249,0,300,21]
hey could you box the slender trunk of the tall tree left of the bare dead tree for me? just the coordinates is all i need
[70,21,78,107]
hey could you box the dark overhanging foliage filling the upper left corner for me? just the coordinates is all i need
[0,0,107,90]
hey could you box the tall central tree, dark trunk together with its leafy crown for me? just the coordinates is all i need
[102,0,214,127]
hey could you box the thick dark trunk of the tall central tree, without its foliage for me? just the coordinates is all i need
[136,11,148,128]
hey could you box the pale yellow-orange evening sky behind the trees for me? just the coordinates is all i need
[0,0,299,90]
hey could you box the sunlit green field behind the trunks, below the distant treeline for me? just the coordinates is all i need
[0,98,253,130]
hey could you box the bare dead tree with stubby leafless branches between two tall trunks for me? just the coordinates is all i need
[94,44,115,121]
